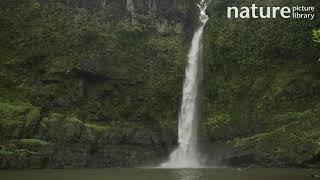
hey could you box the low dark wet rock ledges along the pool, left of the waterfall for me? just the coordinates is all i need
[0,121,167,169]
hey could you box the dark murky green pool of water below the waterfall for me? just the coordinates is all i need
[0,168,319,180]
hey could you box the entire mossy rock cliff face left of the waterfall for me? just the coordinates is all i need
[0,0,197,169]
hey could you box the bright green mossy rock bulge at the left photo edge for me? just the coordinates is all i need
[0,103,40,138]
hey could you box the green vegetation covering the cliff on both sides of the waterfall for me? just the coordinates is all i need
[0,0,320,169]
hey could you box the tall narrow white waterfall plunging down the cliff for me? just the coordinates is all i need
[160,0,208,168]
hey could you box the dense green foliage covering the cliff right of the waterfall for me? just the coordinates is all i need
[202,0,320,165]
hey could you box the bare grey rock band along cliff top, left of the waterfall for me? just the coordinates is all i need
[42,0,197,34]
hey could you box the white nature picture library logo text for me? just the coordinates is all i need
[227,4,315,20]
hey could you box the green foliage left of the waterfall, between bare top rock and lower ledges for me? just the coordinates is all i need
[1,1,185,126]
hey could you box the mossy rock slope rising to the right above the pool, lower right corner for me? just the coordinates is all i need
[228,105,320,167]
